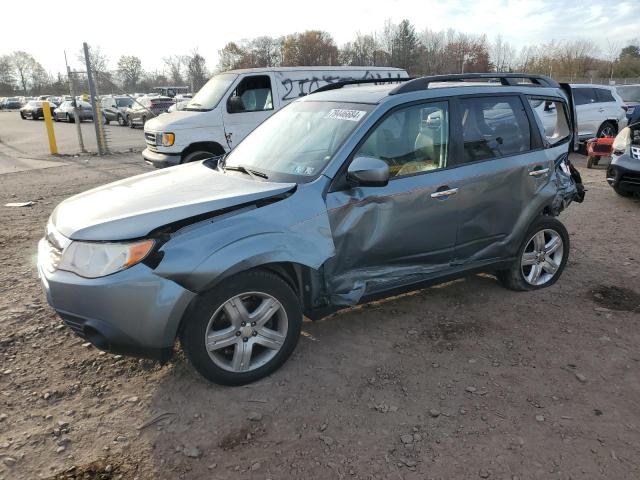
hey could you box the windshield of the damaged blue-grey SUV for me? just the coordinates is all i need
[225,101,374,183]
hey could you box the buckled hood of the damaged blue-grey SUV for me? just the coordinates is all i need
[51,162,295,241]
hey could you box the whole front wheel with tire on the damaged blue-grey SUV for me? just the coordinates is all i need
[180,270,302,385]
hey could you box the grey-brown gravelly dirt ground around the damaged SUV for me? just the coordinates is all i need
[0,136,640,480]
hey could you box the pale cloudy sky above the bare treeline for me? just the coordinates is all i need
[0,0,640,74]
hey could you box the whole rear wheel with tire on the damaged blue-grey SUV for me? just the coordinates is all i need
[497,216,569,291]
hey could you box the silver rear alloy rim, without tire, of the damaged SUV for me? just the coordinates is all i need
[520,229,564,286]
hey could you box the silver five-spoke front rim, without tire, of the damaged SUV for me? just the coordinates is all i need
[205,292,288,372]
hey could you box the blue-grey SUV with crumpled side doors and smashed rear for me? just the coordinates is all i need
[38,74,583,385]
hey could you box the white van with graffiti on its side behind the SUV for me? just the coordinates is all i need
[142,67,408,167]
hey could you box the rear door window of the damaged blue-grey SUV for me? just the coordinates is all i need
[460,97,531,163]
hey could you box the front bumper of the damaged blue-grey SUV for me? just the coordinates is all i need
[38,239,195,360]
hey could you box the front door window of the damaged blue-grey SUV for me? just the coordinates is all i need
[355,102,449,177]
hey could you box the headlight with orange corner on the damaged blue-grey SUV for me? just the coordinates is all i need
[58,240,155,278]
